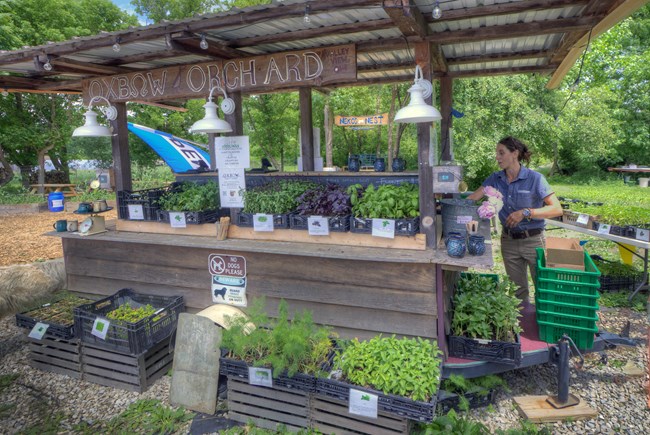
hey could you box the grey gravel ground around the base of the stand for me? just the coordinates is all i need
[0,309,650,434]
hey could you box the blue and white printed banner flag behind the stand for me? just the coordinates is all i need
[128,122,210,174]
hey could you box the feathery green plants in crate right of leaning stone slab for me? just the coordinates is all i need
[221,298,333,377]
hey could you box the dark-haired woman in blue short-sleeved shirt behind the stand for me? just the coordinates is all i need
[468,136,562,311]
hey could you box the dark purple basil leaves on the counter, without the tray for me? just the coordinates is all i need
[297,184,351,217]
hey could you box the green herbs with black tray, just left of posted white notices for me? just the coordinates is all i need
[158,181,220,224]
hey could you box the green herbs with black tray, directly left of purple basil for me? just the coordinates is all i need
[237,180,317,228]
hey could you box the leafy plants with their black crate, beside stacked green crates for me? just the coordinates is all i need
[449,274,522,365]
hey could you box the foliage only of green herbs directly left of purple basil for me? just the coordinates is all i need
[242,180,318,214]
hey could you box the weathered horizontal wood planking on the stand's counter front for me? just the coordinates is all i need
[63,230,437,338]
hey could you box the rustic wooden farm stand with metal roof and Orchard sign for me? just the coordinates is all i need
[0,0,648,430]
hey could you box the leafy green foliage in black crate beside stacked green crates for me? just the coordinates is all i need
[451,275,522,342]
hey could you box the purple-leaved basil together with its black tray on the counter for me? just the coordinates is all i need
[290,183,351,232]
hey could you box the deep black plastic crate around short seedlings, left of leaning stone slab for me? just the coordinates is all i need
[74,288,185,355]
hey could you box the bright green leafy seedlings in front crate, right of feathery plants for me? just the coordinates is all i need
[335,335,442,401]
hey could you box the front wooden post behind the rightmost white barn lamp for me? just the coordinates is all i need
[414,42,437,249]
